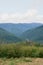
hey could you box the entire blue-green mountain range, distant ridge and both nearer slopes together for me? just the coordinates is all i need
[0,23,43,43]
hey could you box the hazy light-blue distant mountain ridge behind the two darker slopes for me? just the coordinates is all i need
[0,23,42,36]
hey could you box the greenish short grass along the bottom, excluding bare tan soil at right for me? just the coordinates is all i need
[0,58,32,65]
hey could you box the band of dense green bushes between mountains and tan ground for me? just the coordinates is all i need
[0,43,43,58]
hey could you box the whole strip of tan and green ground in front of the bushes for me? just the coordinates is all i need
[0,58,43,65]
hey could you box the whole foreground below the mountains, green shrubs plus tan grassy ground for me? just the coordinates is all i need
[0,43,43,65]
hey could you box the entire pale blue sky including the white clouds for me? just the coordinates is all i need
[0,0,43,23]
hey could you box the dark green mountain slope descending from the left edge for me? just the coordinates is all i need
[0,28,21,43]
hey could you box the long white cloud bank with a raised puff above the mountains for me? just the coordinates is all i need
[0,9,43,23]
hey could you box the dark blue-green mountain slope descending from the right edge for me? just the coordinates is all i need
[20,25,43,42]
